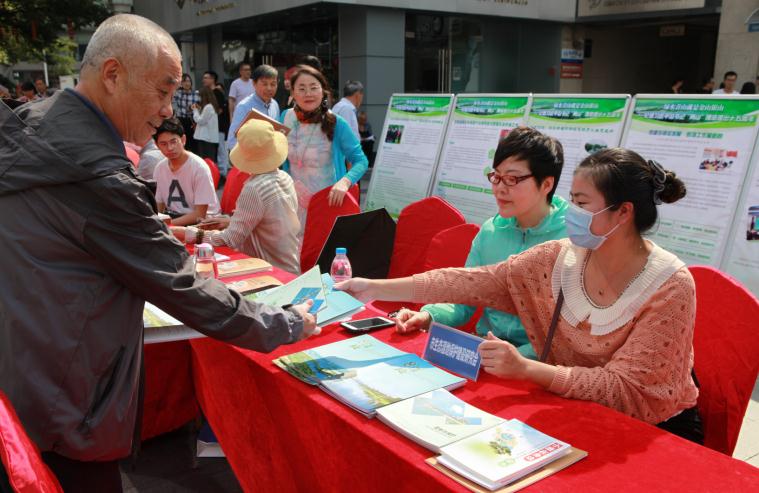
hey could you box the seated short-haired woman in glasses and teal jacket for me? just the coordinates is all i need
[396,127,568,359]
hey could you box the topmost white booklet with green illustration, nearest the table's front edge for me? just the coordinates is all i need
[438,419,572,490]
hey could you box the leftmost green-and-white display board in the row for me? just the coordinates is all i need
[366,94,453,218]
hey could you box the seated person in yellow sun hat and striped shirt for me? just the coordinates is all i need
[171,120,300,274]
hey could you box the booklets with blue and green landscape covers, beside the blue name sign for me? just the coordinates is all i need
[274,335,466,417]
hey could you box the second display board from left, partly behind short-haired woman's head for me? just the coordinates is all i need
[432,94,529,225]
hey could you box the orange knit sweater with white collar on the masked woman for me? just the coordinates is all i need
[413,239,698,424]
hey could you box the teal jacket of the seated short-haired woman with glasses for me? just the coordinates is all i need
[422,196,568,359]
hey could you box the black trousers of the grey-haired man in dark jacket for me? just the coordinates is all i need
[42,452,123,493]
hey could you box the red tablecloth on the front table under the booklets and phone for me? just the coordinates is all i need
[191,270,759,493]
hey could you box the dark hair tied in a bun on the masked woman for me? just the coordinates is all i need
[575,147,686,234]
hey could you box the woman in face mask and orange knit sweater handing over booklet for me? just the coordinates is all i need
[336,148,703,443]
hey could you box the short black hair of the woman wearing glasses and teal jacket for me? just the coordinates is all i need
[493,127,564,204]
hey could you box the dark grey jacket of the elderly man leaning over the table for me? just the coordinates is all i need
[0,90,303,460]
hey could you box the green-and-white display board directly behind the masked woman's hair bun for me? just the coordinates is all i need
[622,95,759,267]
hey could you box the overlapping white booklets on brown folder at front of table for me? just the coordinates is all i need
[377,389,587,491]
